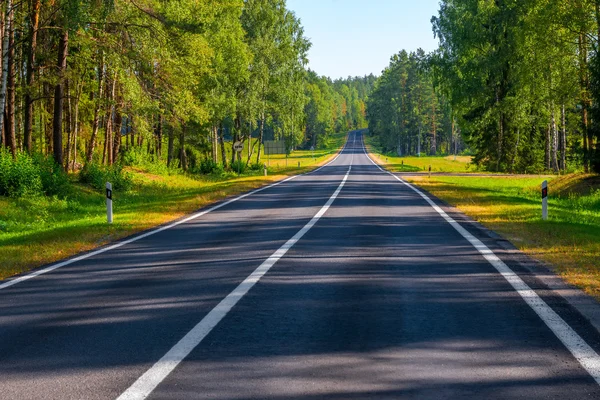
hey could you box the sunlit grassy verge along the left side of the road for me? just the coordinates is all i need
[0,130,346,279]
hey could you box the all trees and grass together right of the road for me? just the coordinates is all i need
[367,0,600,299]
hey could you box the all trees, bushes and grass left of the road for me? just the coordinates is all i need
[0,0,375,279]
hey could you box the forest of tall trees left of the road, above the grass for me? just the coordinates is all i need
[0,0,375,195]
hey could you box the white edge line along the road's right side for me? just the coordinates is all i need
[363,137,600,384]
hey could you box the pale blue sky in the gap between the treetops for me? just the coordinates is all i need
[287,0,439,79]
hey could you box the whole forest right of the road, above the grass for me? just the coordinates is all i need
[367,0,600,173]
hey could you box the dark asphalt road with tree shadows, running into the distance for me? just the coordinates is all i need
[0,132,600,400]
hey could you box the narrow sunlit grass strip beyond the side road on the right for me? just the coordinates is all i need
[365,135,477,172]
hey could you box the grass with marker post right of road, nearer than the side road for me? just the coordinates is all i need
[400,174,600,300]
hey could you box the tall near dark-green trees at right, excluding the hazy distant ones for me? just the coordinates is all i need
[431,0,600,172]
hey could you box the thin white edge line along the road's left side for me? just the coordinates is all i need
[0,137,348,290]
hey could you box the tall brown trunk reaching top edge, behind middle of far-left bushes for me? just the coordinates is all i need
[23,0,41,152]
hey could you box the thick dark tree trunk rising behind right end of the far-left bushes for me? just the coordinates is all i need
[52,29,69,165]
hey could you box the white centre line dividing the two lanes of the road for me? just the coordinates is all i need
[117,165,352,400]
